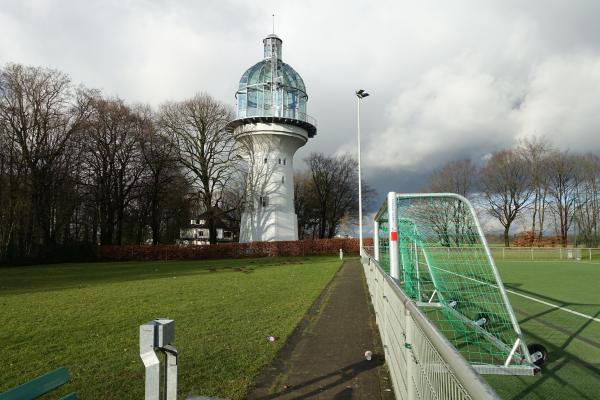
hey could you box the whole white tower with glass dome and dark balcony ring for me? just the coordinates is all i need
[228,34,317,242]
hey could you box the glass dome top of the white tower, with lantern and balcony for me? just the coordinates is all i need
[229,34,317,137]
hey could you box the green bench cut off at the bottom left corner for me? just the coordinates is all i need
[0,368,77,400]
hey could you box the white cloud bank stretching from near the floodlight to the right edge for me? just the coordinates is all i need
[367,53,600,169]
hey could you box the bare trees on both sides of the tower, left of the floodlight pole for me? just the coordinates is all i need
[0,64,366,261]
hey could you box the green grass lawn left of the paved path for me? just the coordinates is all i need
[0,257,341,399]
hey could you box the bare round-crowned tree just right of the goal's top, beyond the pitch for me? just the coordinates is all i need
[480,150,533,247]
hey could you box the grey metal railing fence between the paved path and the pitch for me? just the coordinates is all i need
[362,255,499,400]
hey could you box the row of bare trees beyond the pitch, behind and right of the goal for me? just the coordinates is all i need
[427,138,600,247]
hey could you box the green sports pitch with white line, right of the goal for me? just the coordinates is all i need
[486,257,600,400]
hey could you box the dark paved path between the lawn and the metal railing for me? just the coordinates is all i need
[248,260,394,400]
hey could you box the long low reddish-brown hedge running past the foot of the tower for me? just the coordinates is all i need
[97,238,373,261]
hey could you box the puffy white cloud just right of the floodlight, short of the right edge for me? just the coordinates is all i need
[367,56,519,167]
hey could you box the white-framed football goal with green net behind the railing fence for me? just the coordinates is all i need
[375,193,545,375]
